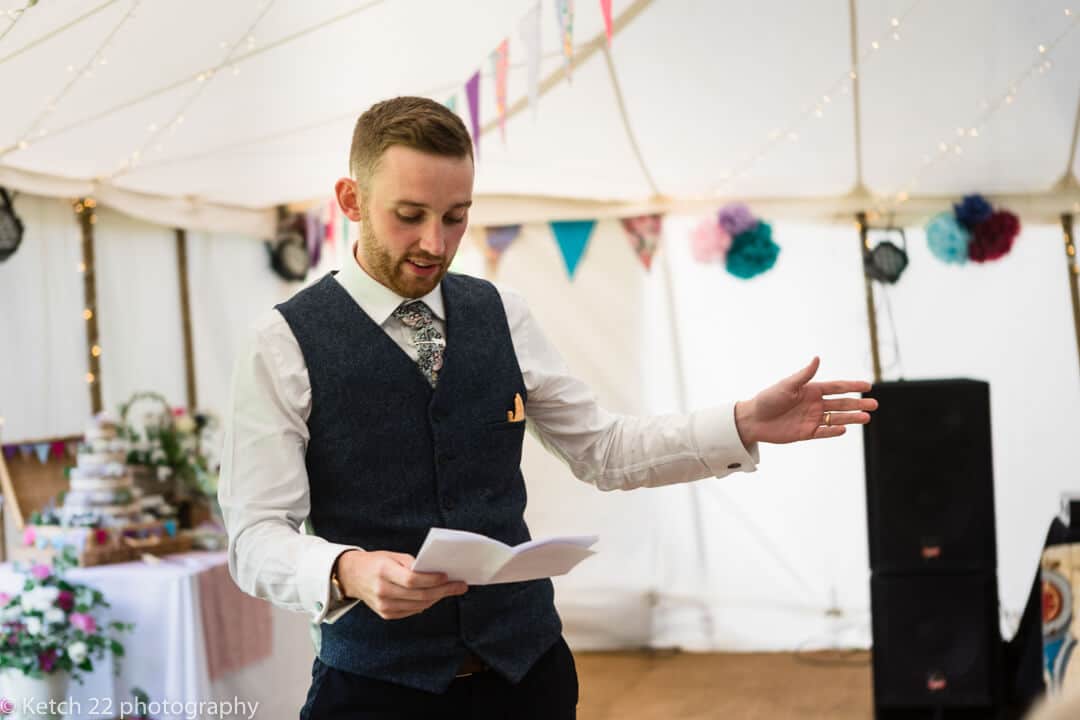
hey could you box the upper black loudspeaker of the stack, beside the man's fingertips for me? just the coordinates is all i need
[863,380,997,572]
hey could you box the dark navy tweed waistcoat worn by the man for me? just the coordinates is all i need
[278,269,562,692]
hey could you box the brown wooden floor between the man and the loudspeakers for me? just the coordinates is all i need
[575,651,873,720]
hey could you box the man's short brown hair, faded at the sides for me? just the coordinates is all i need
[349,96,473,187]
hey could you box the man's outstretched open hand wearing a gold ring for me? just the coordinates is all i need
[735,357,877,447]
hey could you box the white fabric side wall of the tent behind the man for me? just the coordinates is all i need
[0,198,1080,650]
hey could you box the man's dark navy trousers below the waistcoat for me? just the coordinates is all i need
[300,638,578,720]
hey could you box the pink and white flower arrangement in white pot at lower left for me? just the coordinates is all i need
[0,552,133,716]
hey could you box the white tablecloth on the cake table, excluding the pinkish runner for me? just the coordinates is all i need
[0,553,314,720]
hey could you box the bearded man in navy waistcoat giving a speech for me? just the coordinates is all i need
[220,97,876,720]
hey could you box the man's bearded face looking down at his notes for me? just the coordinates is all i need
[357,145,473,298]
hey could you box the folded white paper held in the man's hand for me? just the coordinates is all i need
[413,528,598,585]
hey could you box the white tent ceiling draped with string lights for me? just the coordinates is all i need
[0,0,1080,232]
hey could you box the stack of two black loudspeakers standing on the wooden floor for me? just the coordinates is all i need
[863,380,1004,720]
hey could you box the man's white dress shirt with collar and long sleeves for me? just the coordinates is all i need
[218,252,758,623]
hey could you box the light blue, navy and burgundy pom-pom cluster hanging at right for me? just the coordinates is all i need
[926,194,1021,264]
